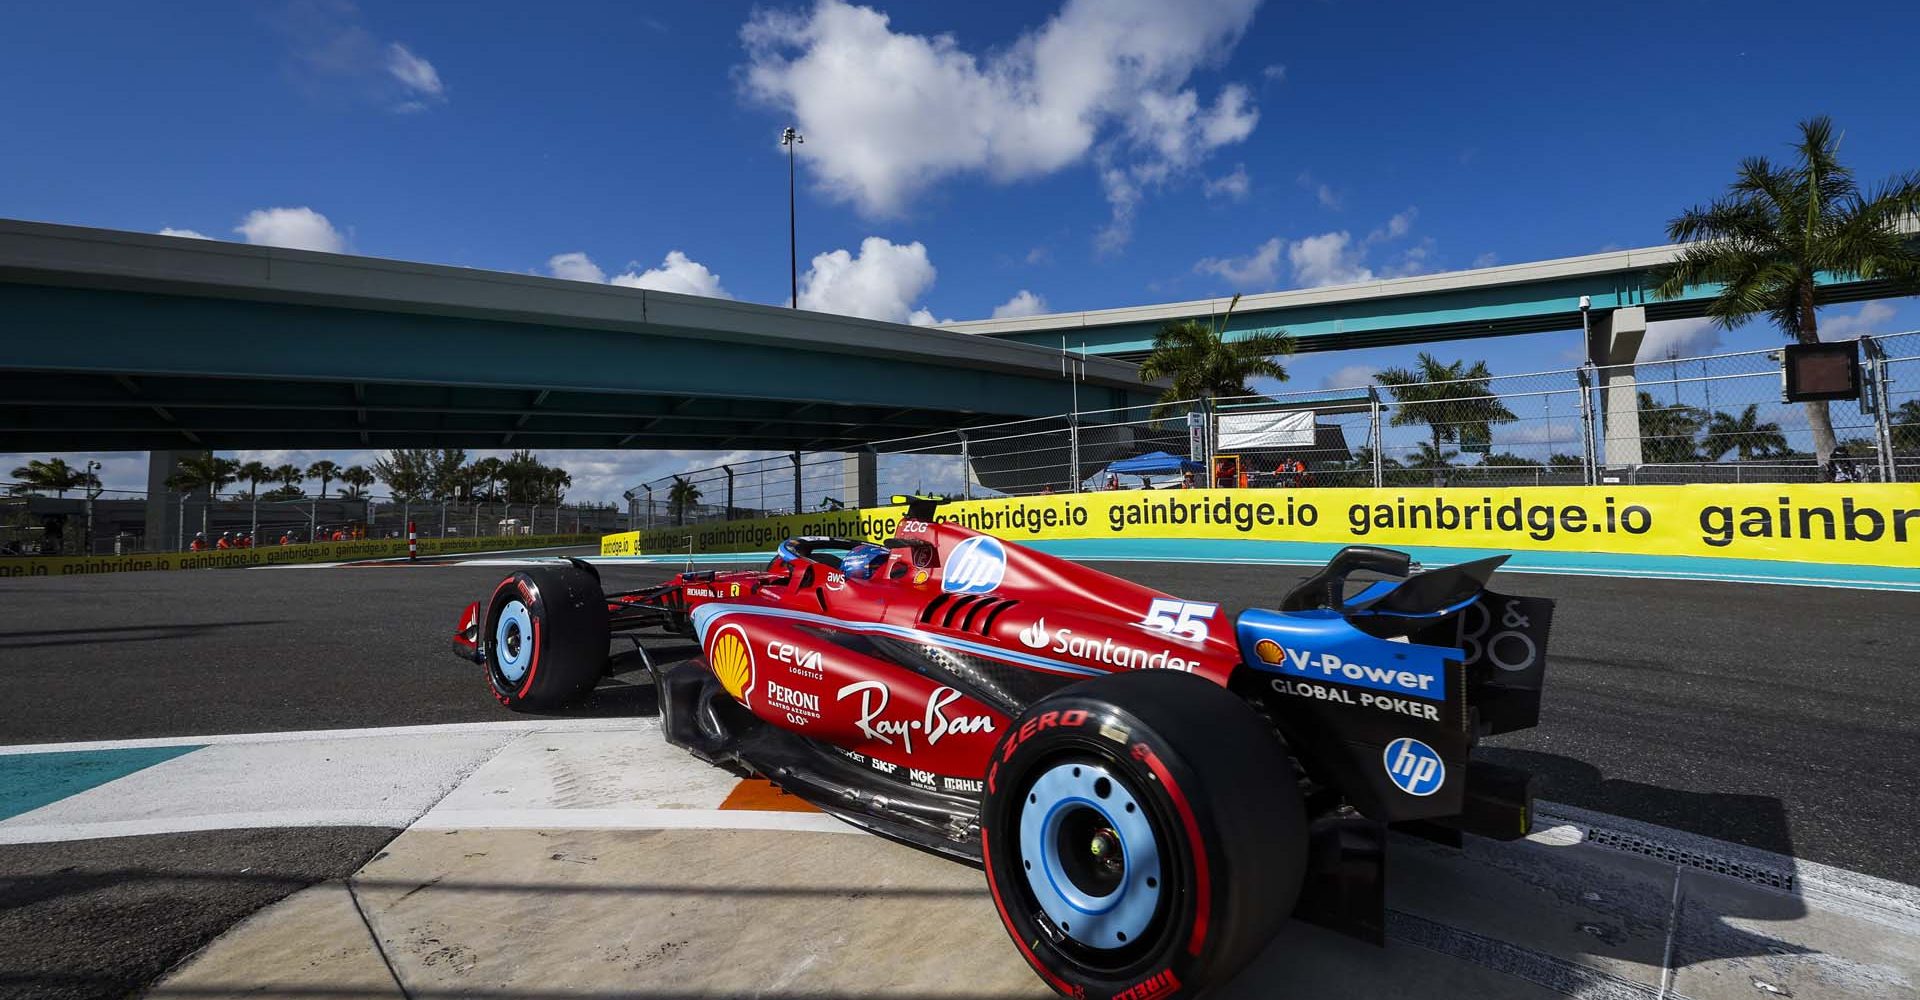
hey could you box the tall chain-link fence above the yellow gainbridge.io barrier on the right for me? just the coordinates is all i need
[630,332,1920,526]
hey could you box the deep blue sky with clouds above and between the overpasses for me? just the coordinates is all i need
[0,0,1920,499]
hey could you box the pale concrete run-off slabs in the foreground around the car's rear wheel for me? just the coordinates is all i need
[0,720,1896,998]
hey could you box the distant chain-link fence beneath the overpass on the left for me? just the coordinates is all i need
[0,482,628,555]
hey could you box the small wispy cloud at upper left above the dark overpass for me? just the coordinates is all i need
[275,0,447,113]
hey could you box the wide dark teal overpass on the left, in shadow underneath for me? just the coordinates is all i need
[0,221,1158,451]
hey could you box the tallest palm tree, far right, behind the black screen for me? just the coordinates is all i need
[1653,115,1920,476]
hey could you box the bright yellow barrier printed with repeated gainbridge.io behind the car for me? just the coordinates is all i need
[601,484,1920,568]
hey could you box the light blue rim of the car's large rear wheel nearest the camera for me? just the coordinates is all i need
[1020,762,1165,950]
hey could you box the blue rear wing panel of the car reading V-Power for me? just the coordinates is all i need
[1235,608,1465,702]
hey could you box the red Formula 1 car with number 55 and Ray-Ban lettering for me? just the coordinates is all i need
[455,501,1551,1000]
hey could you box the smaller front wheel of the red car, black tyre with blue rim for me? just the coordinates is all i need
[484,566,609,712]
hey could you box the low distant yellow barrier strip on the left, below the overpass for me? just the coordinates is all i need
[0,534,601,578]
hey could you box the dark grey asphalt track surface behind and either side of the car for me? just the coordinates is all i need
[0,545,1920,883]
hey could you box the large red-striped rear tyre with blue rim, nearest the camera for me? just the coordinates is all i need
[981,670,1306,1000]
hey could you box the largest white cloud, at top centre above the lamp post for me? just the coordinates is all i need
[741,0,1260,248]
